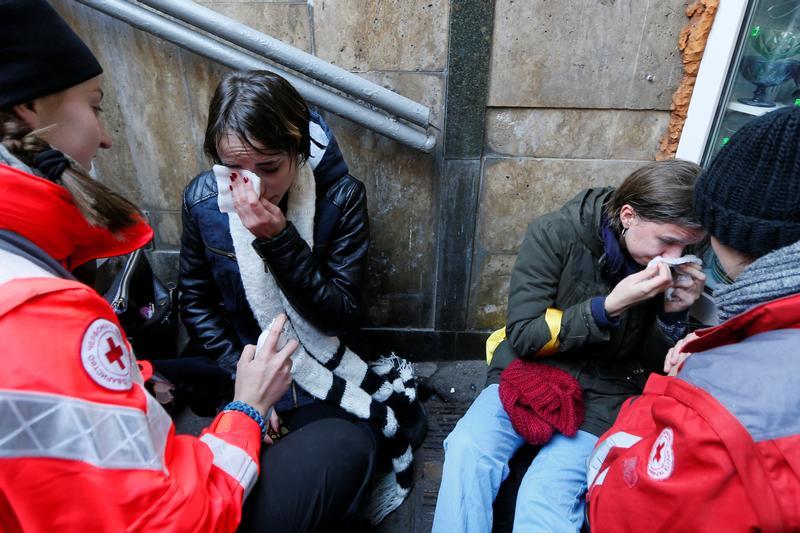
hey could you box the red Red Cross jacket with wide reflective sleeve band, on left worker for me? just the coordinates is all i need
[0,165,261,532]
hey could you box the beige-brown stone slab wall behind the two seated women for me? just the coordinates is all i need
[52,0,686,336]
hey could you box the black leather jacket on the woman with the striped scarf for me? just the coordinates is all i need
[179,113,369,382]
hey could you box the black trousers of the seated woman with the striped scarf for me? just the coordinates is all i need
[239,403,378,533]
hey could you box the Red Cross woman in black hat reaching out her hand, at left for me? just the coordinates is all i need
[0,0,297,532]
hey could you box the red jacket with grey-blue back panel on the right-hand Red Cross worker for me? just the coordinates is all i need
[587,295,800,533]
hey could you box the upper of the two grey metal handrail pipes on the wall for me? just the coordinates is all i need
[138,0,431,128]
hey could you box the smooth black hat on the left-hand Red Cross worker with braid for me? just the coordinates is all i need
[0,0,103,110]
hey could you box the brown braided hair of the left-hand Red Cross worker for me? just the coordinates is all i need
[0,111,140,232]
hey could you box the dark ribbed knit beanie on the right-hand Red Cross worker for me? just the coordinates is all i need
[694,106,800,257]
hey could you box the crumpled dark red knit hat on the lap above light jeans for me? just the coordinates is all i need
[500,359,584,444]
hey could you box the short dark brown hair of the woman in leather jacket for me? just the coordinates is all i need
[203,70,311,164]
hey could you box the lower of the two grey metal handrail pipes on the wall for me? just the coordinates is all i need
[78,0,436,152]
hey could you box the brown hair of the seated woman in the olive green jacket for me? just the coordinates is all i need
[604,159,703,235]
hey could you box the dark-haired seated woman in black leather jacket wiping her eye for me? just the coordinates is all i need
[179,71,377,531]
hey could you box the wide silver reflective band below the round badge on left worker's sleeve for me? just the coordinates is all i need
[0,390,172,470]
